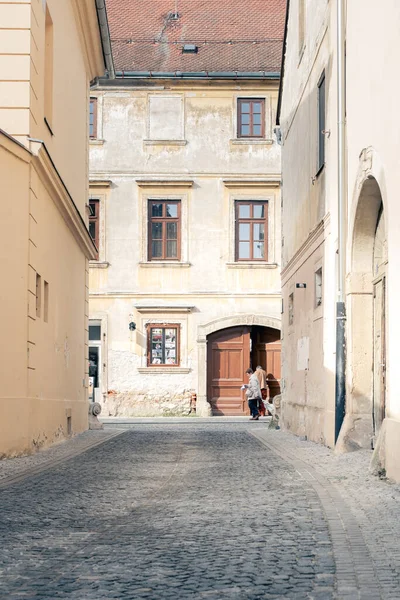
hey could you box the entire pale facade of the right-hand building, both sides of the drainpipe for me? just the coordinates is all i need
[280,0,400,480]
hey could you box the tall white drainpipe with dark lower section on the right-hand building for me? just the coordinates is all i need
[335,0,347,443]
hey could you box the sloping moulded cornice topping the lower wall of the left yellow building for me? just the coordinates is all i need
[32,143,97,260]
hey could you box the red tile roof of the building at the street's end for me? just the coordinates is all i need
[106,0,286,72]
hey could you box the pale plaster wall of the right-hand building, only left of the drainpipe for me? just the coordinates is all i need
[281,0,337,445]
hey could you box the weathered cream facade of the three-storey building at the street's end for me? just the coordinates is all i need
[90,80,281,415]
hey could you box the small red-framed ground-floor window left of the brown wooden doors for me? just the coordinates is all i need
[147,324,179,366]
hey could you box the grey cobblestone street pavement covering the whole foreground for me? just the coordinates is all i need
[0,422,400,600]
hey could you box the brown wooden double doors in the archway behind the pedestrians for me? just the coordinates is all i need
[207,325,281,416]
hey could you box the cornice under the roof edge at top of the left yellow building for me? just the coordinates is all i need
[72,0,105,81]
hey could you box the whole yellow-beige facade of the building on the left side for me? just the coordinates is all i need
[0,0,104,456]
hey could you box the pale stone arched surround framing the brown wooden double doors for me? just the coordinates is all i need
[197,313,281,416]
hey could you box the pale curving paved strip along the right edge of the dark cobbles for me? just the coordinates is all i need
[249,431,384,600]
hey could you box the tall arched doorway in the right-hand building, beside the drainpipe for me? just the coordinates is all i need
[346,176,387,447]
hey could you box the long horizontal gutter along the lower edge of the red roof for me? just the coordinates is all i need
[108,70,280,80]
